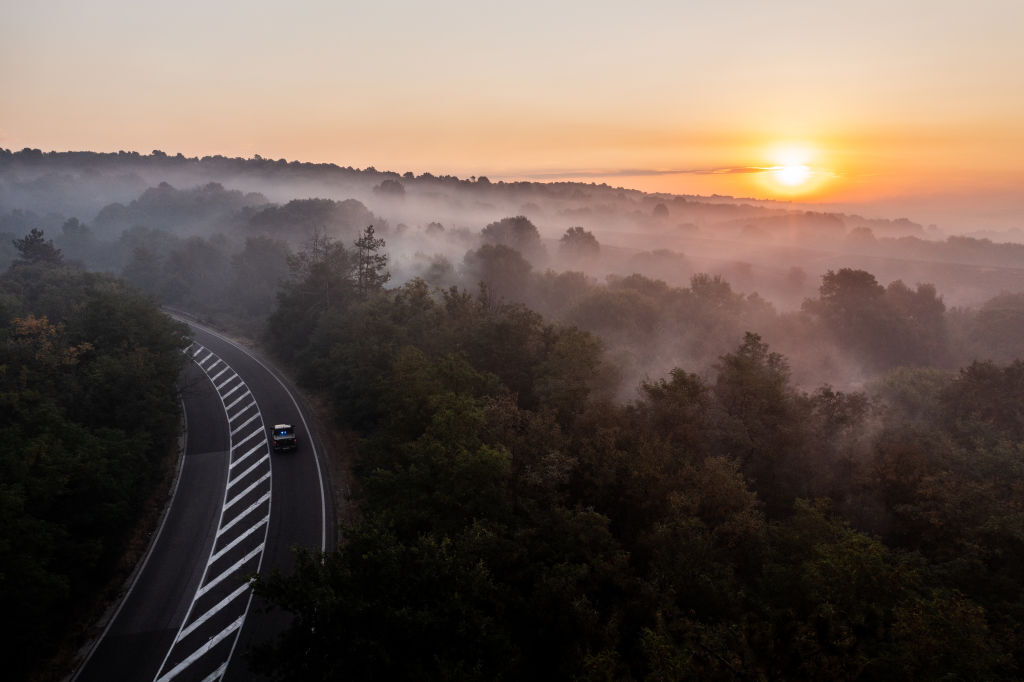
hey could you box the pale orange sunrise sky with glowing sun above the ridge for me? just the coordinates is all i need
[0,0,1024,223]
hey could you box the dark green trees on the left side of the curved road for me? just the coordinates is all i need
[0,238,183,679]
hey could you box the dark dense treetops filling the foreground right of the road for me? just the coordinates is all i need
[249,235,1024,680]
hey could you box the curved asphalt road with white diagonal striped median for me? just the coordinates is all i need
[75,318,335,682]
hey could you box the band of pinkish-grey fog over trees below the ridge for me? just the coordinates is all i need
[0,150,1024,399]
